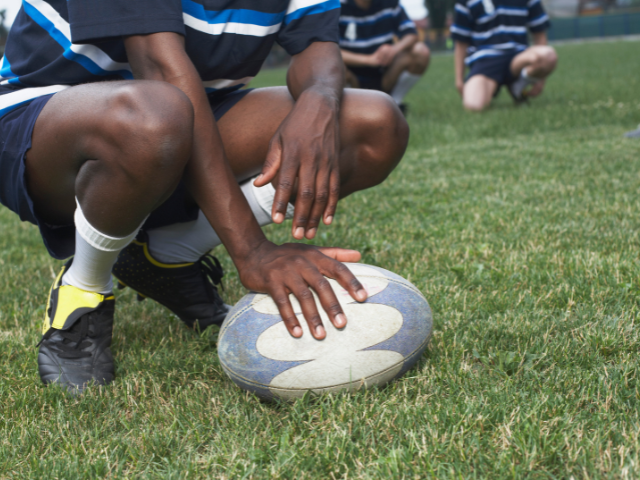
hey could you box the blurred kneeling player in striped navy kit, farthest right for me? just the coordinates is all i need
[451,0,558,111]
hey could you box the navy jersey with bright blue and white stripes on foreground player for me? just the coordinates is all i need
[0,0,340,116]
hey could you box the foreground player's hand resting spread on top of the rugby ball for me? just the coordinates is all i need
[238,240,367,340]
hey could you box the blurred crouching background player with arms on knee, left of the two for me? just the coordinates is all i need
[340,0,430,113]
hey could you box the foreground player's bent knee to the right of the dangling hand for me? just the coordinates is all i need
[363,92,409,184]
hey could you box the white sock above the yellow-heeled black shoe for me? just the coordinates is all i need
[62,199,139,293]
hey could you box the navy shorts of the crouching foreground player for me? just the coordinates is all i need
[0,89,251,260]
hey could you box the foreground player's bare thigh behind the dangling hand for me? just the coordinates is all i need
[218,87,406,181]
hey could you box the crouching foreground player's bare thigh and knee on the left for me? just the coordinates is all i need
[25,81,192,223]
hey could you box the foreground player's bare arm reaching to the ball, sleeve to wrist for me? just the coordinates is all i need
[125,33,265,265]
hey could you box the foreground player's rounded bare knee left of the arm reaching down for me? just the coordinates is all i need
[106,82,193,181]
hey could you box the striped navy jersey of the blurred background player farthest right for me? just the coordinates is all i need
[451,0,550,65]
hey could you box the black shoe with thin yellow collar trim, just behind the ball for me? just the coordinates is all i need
[113,233,230,330]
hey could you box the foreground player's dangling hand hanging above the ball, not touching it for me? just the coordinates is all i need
[254,89,340,240]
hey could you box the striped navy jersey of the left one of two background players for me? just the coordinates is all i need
[340,0,417,54]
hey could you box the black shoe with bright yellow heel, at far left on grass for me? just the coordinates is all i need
[38,262,115,394]
